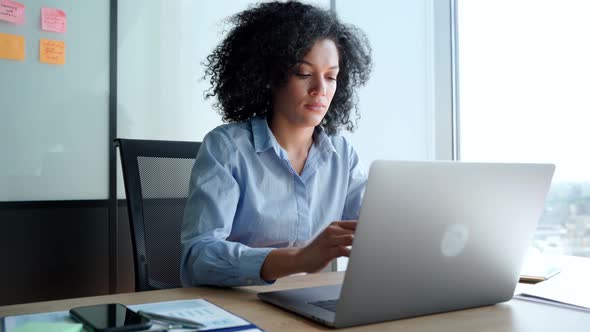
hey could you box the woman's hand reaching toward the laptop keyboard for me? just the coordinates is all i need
[296,220,356,273]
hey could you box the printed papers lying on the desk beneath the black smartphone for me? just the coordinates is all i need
[0,299,262,332]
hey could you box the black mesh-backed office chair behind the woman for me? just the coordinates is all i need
[114,138,201,291]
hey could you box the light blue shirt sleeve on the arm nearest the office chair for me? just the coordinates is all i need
[180,130,272,286]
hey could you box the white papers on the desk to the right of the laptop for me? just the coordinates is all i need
[515,269,590,311]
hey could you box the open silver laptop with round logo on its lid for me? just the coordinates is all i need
[258,161,555,328]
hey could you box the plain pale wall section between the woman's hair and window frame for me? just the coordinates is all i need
[336,0,434,166]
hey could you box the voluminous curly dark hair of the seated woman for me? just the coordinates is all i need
[204,1,372,135]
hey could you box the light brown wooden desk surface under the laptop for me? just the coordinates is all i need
[0,272,590,332]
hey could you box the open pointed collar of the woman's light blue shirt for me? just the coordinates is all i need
[250,115,338,157]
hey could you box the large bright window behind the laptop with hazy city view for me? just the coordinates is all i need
[456,0,590,256]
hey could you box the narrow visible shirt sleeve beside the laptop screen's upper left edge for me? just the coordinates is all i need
[342,140,367,220]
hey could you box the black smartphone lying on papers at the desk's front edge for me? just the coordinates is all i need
[70,303,152,332]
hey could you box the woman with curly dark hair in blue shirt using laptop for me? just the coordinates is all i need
[181,2,371,286]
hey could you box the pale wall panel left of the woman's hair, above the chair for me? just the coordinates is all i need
[117,0,329,141]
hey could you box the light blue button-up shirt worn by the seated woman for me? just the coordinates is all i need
[180,116,367,286]
